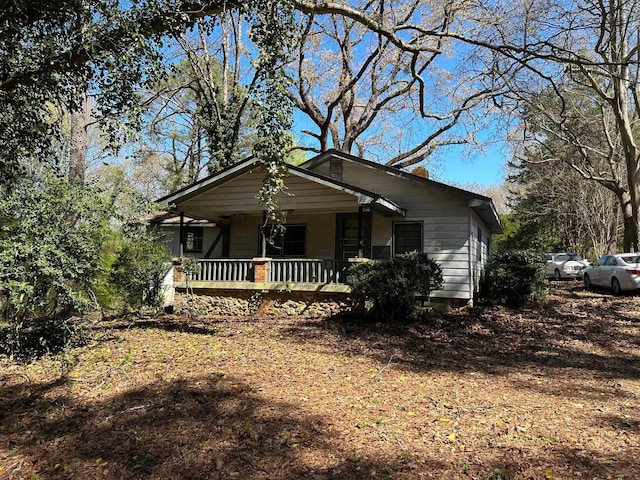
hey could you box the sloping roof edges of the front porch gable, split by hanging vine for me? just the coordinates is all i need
[157,157,406,216]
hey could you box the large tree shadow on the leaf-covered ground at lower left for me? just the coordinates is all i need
[0,375,450,480]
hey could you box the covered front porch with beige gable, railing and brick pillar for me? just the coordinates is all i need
[165,161,405,293]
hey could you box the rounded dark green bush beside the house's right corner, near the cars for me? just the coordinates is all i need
[485,250,547,308]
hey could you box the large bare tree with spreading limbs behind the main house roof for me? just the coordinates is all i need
[292,0,501,168]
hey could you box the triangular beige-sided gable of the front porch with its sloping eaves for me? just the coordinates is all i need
[158,159,405,221]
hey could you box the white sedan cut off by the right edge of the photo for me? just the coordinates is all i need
[584,253,640,295]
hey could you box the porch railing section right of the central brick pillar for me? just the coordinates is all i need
[269,258,349,284]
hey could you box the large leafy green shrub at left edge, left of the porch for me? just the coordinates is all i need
[0,177,109,356]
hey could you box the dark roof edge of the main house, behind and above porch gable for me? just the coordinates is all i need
[300,149,504,233]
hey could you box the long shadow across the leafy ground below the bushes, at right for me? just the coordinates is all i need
[285,284,640,379]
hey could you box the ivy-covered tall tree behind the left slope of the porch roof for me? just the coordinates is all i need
[140,11,256,190]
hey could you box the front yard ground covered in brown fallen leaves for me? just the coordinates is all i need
[0,282,640,480]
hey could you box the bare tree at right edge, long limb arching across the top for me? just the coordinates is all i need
[295,0,640,250]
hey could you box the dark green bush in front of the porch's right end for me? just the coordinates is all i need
[347,252,444,321]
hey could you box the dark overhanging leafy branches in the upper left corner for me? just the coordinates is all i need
[0,0,172,188]
